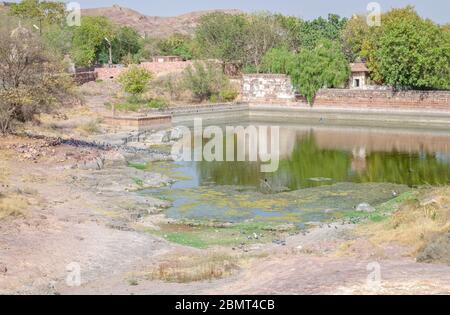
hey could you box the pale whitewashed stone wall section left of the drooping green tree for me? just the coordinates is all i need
[242,74,295,103]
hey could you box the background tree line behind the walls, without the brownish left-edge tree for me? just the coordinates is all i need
[7,0,450,93]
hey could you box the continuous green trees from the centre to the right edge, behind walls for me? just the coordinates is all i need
[195,7,450,99]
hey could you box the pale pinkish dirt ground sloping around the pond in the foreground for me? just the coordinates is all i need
[0,82,450,294]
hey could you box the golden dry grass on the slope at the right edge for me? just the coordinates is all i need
[358,187,450,255]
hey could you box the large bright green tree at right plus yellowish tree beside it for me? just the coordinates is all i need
[343,6,450,89]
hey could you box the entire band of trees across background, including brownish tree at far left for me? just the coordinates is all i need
[0,0,450,130]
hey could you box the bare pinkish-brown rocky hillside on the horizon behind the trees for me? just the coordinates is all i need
[82,5,240,37]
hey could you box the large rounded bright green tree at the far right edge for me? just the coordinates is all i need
[372,7,450,89]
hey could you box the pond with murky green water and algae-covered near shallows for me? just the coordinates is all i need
[145,125,450,224]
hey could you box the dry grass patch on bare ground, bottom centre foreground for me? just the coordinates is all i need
[145,252,252,283]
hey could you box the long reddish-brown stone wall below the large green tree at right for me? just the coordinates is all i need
[314,89,450,111]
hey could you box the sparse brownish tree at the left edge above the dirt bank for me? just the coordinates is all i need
[0,25,72,133]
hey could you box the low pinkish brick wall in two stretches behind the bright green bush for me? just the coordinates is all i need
[95,61,192,80]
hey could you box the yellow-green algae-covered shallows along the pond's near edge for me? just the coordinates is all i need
[152,183,409,226]
